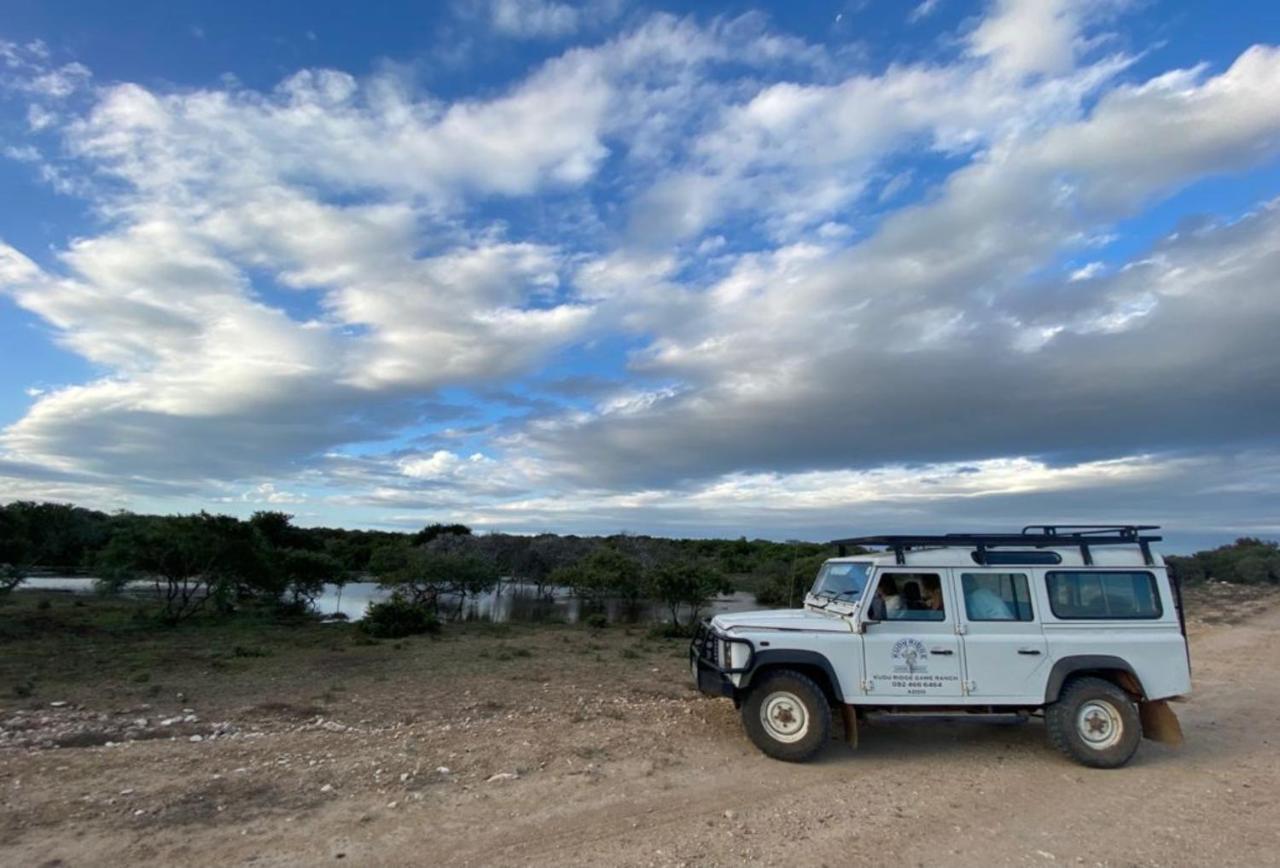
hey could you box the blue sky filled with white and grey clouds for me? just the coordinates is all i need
[0,0,1280,551]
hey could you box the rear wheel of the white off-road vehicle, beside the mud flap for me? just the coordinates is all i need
[1044,677,1142,768]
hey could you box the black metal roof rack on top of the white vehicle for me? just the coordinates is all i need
[832,525,1164,566]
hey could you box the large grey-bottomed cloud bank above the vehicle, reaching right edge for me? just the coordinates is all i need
[530,47,1280,494]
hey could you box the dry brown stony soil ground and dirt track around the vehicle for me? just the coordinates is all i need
[0,589,1280,865]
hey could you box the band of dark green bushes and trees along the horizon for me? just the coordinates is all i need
[0,502,1280,639]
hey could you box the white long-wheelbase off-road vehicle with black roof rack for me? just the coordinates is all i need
[689,525,1190,768]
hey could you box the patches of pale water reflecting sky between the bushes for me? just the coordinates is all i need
[19,576,760,623]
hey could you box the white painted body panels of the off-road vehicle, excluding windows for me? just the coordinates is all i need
[694,545,1190,708]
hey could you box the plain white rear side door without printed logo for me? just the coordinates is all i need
[952,567,1048,704]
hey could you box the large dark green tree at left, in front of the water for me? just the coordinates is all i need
[99,512,272,623]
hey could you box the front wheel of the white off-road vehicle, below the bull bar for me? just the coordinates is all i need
[742,670,831,763]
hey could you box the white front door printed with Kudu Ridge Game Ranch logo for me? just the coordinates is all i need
[859,568,961,705]
